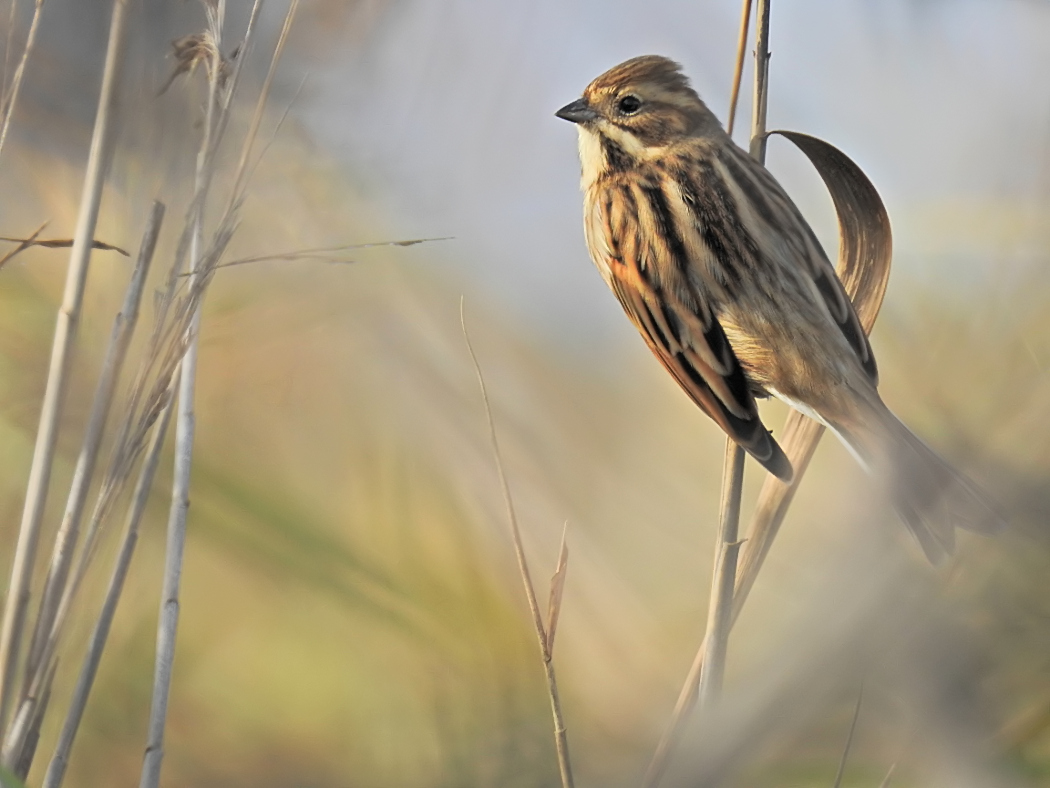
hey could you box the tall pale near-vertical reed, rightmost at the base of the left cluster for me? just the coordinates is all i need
[140,0,224,788]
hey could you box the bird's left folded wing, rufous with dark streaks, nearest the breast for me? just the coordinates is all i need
[587,178,792,481]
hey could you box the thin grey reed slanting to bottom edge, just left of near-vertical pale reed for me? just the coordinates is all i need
[43,397,177,788]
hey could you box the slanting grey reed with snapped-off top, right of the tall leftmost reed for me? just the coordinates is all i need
[3,202,164,764]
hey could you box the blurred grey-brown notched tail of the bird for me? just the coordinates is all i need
[834,399,1004,564]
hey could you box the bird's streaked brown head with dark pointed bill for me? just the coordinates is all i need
[555,55,721,177]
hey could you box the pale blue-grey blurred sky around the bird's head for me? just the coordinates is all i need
[299,0,1050,347]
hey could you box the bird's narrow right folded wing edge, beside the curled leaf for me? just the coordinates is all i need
[718,145,879,383]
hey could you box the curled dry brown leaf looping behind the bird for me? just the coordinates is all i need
[733,131,893,618]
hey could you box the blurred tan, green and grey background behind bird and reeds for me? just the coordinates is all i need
[0,0,1050,788]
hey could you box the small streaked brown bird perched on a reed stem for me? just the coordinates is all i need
[557,56,1000,563]
